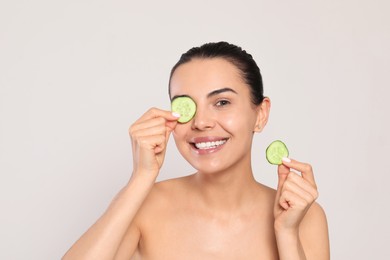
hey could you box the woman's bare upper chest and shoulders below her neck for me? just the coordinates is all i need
[128,175,278,259]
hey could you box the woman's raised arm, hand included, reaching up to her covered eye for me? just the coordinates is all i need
[63,109,178,260]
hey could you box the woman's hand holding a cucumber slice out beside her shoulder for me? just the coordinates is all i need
[274,158,318,234]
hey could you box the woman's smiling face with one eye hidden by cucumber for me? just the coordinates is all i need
[170,58,268,173]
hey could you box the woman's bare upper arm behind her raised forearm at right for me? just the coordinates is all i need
[299,202,330,259]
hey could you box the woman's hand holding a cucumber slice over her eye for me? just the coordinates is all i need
[129,108,180,178]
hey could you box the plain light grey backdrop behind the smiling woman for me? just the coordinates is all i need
[0,0,390,260]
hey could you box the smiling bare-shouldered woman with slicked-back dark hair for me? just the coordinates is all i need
[64,42,329,260]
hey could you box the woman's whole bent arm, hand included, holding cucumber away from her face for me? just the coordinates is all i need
[274,159,330,260]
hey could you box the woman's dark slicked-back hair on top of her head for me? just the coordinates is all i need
[169,42,264,105]
